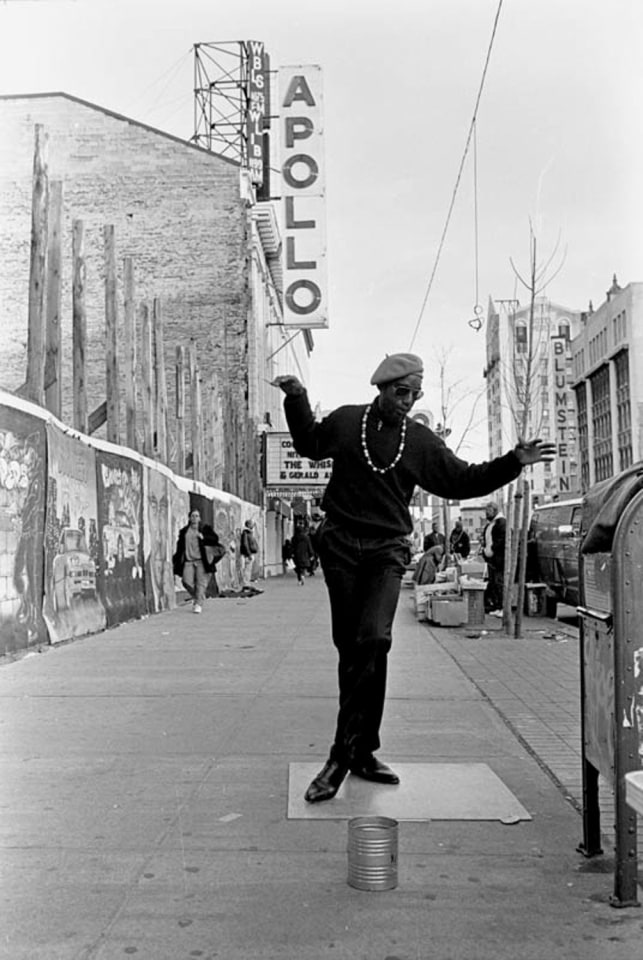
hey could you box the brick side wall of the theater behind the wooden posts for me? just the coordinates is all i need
[0,93,302,502]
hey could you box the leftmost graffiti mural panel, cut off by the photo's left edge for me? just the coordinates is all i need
[0,407,48,654]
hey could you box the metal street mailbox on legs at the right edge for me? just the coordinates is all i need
[578,463,643,907]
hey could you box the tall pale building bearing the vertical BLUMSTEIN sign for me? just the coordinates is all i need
[484,297,581,503]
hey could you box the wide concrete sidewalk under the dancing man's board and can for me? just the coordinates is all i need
[0,577,643,960]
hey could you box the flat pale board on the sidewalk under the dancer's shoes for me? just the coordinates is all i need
[288,761,531,823]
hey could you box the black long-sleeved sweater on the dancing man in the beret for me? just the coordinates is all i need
[284,393,522,537]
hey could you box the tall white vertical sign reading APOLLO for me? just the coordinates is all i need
[279,65,328,328]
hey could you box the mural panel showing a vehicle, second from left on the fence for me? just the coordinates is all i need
[43,424,106,643]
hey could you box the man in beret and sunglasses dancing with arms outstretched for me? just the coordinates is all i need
[276,353,554,803]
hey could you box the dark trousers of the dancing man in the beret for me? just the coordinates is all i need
[319,519,409,764]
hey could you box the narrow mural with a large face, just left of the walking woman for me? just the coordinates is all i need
[143,467,176,613]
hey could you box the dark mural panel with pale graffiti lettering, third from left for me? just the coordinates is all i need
[96,450,147,627]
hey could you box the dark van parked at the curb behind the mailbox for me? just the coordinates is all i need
[528,497,583,617]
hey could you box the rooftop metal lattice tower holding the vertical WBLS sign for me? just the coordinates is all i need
[192,40,270,187]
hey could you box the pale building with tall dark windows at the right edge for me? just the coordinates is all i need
[572,277,643,492]
